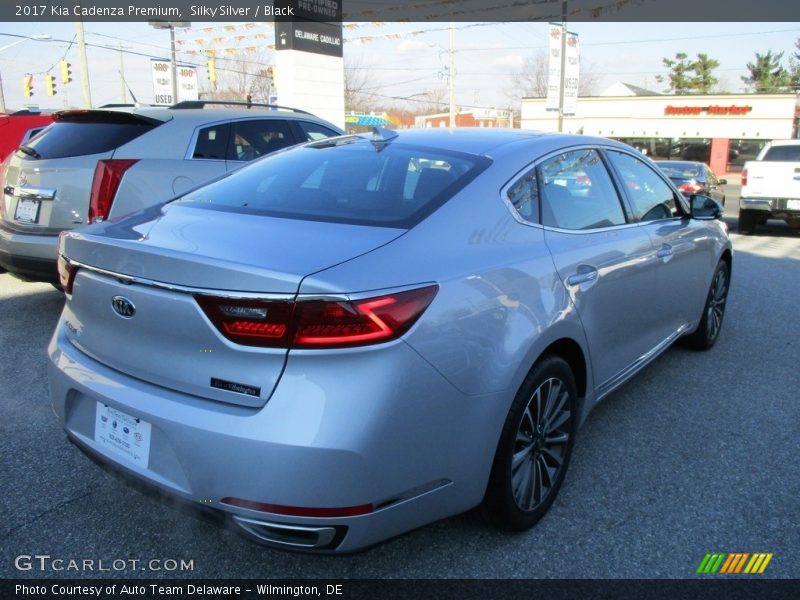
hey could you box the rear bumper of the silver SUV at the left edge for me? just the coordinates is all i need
[0,225,58,283]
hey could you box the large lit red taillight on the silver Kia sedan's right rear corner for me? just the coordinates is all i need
[195,285,439,348]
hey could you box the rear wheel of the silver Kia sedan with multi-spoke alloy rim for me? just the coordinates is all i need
[480,356,578,531]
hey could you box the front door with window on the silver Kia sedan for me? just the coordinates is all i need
[606,149,717,340]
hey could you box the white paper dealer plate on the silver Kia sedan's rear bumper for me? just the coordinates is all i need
[94,402,151,469]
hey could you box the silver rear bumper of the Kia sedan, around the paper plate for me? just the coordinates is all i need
[49,320,508,553]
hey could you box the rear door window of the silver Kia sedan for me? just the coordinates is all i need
[539,149,626,230]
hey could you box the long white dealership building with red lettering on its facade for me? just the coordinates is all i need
[521,82,798,173]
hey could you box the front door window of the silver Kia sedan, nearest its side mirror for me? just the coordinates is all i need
[608,150,680,221]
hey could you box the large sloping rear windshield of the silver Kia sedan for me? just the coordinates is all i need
[177,138,491,228]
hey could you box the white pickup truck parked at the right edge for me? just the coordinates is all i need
[739,140,800,235]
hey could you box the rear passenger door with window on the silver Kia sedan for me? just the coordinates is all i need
[539,148,658,394]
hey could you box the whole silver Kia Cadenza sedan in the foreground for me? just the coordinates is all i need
[49,130,732,552]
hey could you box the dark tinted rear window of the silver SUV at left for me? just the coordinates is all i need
[18,120,155,160]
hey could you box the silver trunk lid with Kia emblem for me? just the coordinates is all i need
[61,205,404,406]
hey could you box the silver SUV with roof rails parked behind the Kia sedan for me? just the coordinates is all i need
[0,102,342,283]
